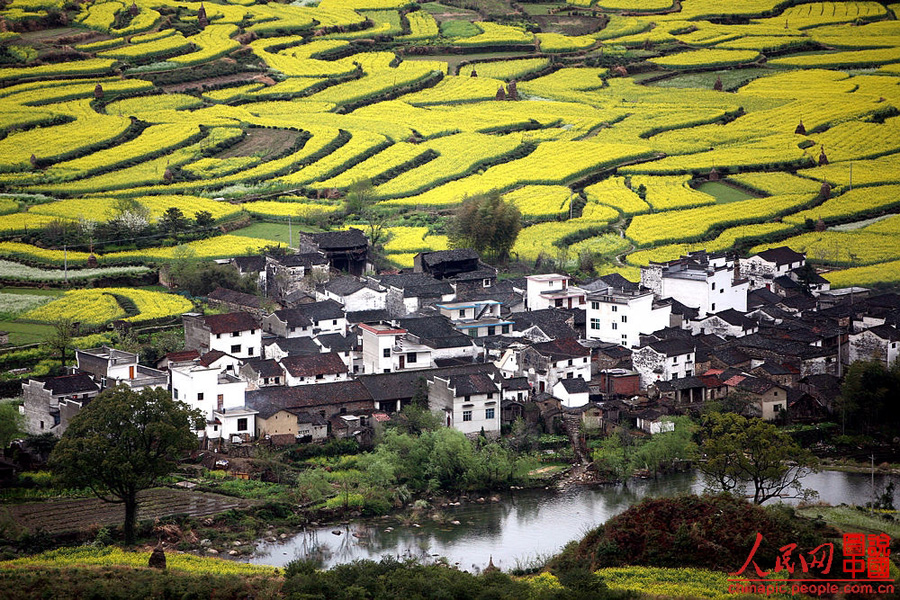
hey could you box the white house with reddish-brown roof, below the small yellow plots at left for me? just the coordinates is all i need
[182,312,262,358]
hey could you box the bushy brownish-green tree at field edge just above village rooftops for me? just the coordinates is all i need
[447,192,522,261]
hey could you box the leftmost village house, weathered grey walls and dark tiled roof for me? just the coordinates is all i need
[19,373,100,437]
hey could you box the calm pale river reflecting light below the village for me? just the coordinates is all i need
[248,471,900,571]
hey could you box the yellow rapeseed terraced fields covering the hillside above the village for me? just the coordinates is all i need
[0,0,900,292]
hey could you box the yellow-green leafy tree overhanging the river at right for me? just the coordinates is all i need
[700,413,818,504]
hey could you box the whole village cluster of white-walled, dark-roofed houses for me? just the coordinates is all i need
[22,229,900,443]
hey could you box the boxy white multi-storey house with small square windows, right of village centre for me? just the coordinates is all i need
[585,288,672,348]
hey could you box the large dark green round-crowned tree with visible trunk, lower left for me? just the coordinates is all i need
[50,386,202,544]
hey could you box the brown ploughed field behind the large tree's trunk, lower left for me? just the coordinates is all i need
[0,488,257,534]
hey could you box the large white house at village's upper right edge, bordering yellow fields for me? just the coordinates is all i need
[641,252,750,317]
